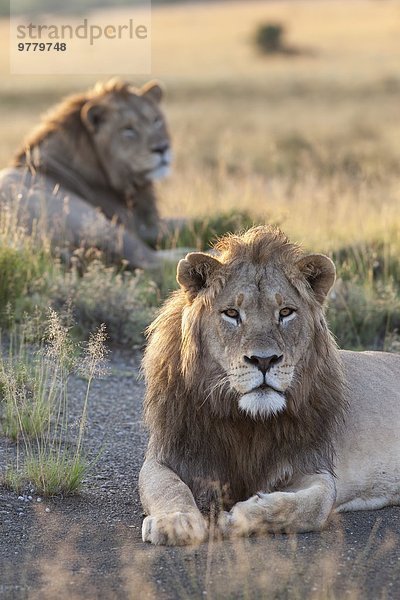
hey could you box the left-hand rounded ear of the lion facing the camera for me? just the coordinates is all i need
[176,252,221,301]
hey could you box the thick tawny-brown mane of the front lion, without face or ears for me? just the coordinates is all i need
[143,227,346,509]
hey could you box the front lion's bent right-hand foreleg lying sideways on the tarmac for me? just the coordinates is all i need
[223,473,336,536]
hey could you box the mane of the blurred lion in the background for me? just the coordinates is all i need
[11,79,164,243]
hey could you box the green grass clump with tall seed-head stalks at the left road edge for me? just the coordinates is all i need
[0,309,106,495]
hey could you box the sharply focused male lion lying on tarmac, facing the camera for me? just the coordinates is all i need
[139,226,400,545]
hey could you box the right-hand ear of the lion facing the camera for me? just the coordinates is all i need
[297,254,336,304]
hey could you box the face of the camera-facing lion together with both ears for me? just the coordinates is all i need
[178,232,335,416]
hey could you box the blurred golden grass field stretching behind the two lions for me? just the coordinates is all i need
[0,0,400,348]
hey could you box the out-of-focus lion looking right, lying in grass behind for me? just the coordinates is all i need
[0,79,177,268]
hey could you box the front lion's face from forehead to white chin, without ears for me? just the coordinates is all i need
[205,265,312,414]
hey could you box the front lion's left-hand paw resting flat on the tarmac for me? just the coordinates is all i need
[142,512,208,546]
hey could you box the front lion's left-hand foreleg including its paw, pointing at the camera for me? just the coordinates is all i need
[139,458,208,546]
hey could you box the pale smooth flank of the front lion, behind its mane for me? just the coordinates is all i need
[336,351,400,510]
